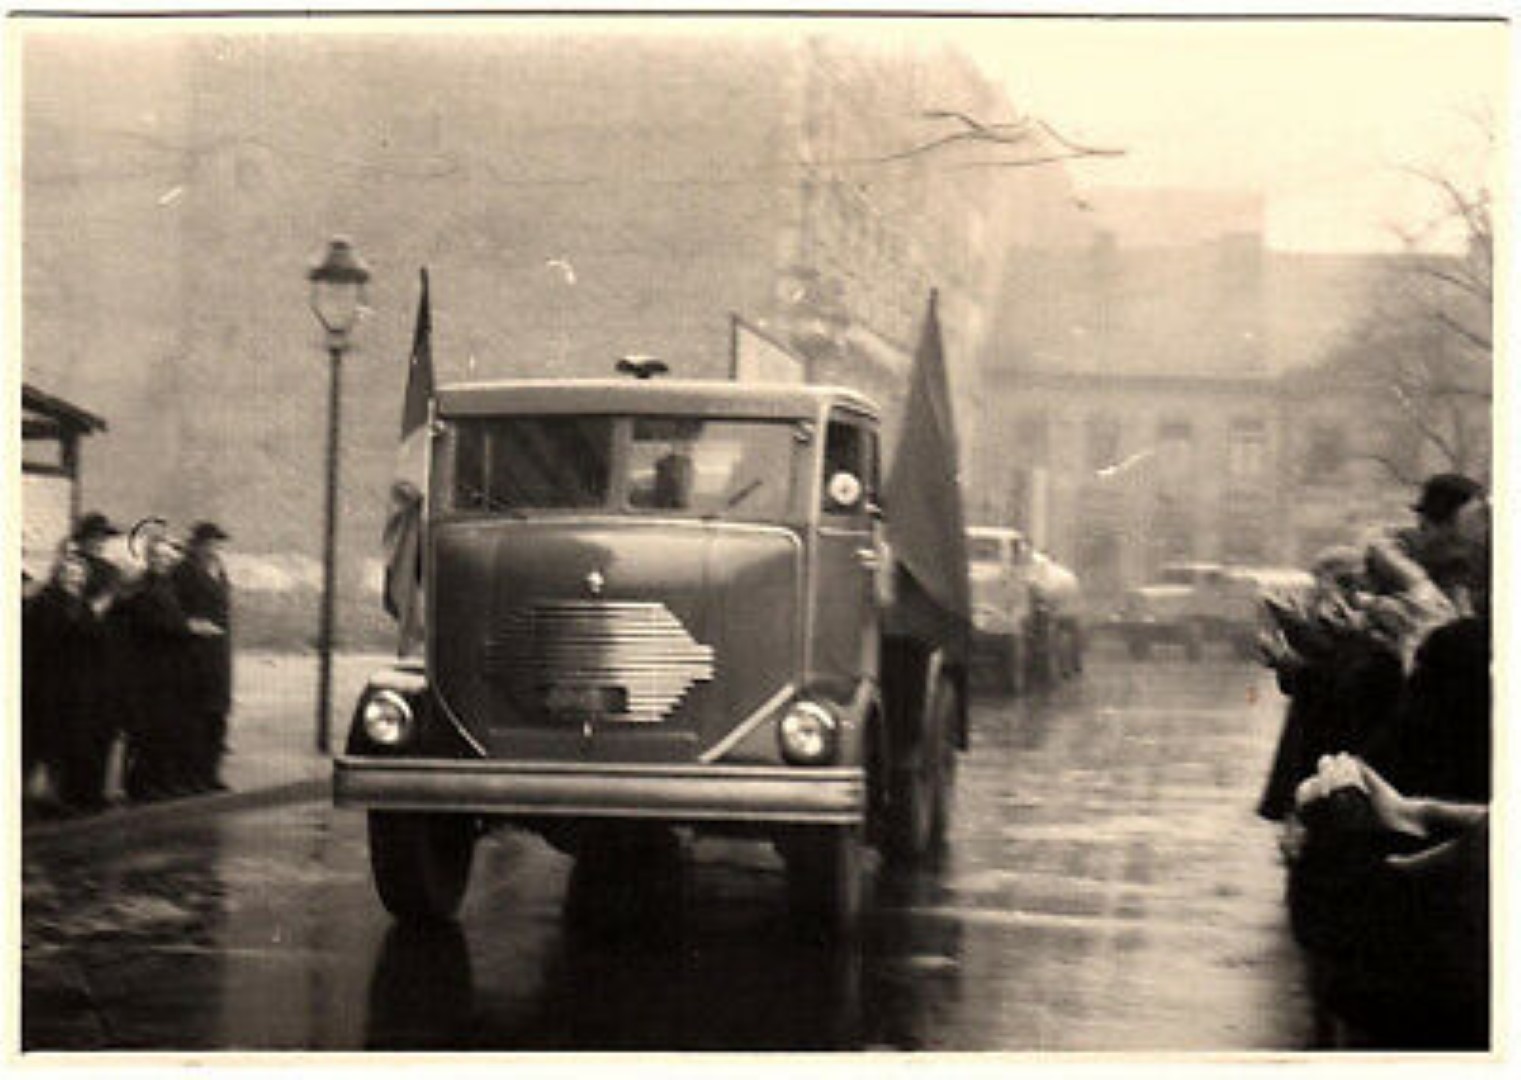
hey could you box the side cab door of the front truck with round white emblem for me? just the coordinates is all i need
[811,414,884,694]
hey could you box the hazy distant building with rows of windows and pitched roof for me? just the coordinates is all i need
[972,192,1491,602]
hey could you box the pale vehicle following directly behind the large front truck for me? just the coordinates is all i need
[967,526,1084,694]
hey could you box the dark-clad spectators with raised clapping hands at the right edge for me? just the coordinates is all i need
[1258,473,1492,1050]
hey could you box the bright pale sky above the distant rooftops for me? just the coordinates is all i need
[946,18,1510,251]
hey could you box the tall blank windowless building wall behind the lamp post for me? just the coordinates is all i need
[21,24,1051,636]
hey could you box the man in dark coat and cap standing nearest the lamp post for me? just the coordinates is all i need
[173,522,233,791]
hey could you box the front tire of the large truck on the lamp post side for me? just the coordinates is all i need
[370,811,476,923]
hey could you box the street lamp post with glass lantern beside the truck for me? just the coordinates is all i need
[306,236,370,754]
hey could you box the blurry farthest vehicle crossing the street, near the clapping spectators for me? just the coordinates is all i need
[1112,563,1313,660]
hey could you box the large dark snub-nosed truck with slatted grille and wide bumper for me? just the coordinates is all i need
[333,357,970,935]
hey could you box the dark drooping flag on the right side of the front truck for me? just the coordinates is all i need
[882,292,972,636]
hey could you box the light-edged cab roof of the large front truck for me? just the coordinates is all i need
[437,379,881,420]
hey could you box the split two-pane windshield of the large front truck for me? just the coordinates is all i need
[446,415,797,520]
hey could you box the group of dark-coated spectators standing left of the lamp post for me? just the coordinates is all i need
[21,513,233,815]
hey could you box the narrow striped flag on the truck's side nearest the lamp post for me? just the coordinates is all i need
[385,268,433,656]
